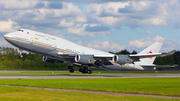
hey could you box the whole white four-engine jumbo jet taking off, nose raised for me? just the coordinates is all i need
[4,29,175,74]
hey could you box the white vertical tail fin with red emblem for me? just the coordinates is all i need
[138,42,162,64]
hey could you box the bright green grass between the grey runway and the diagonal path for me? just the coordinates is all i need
[0,78,180,96]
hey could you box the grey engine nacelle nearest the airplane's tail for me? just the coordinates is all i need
[113,55,127,65]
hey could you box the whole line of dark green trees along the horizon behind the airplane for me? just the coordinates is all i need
[0,47,180,70]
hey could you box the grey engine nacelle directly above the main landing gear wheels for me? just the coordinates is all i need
[75,55,90,64]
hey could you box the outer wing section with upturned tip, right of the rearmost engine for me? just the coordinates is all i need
[129,50,176,58]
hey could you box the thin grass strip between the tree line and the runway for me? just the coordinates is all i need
[0,71,180,75]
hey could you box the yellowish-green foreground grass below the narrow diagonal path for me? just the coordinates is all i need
[0,86,179,101]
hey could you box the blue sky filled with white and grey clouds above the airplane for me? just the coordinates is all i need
[0,0,180,52]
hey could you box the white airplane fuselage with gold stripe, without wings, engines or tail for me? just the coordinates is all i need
[4,29,143,70]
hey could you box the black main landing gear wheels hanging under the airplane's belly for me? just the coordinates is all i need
[68,66,92,74]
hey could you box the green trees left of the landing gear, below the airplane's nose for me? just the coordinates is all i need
[0,47,68,70]
